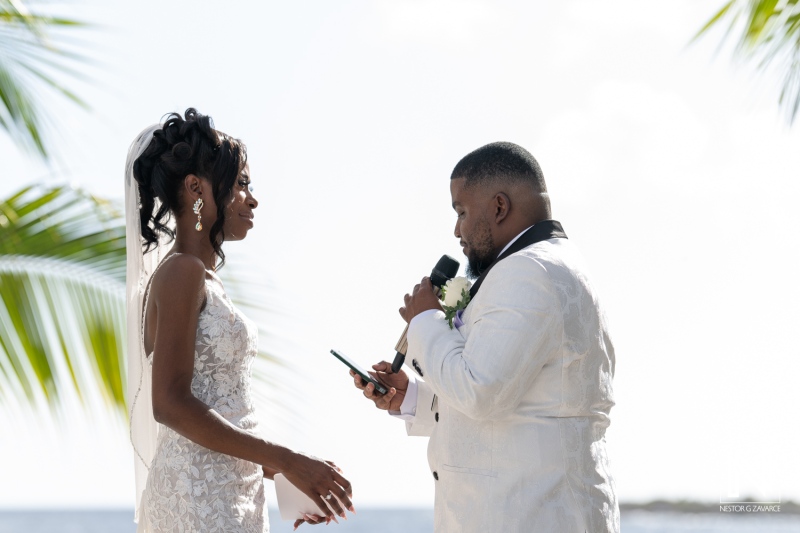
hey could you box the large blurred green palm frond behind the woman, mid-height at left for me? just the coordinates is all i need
[0,187,286,412]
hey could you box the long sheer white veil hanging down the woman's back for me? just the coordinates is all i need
[125,124,167,522]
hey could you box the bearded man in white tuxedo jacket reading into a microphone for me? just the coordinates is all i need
[355,143,619,533]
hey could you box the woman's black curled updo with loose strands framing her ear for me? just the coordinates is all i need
[133,107,247,266]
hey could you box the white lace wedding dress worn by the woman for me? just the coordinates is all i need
[139,272,269,533]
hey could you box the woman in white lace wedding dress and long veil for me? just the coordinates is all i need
[125,108,354,533]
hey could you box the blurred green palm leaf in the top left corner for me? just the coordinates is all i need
[0,0,87,158]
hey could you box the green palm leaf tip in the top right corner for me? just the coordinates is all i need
[695,0,800,123]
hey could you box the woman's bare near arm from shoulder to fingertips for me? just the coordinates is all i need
[148,254,353,516]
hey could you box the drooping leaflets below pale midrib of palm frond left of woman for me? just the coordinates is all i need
[0,255,125,407]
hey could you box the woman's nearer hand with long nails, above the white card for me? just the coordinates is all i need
[281,452,356,525]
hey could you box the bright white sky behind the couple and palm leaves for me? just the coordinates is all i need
[0,0,800,508]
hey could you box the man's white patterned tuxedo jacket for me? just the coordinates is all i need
[406,238,619,533]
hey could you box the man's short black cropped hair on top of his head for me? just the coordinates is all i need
[450,142,547,193]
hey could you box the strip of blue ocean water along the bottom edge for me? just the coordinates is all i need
[0,509,800,533]
